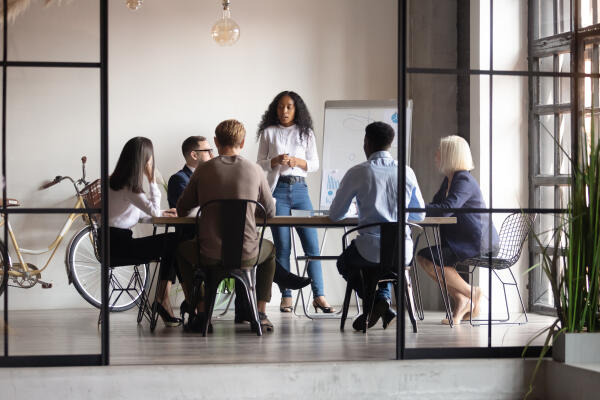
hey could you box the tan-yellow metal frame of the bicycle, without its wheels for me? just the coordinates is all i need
[0,194,89,277]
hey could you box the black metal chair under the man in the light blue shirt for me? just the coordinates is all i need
[340,222,417,333]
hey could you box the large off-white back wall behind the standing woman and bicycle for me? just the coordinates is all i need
[7,0,397,309]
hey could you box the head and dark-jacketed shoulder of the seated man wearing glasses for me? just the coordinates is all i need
[167,136,213,208]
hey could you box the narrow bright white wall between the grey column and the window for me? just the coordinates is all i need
[471,0,529,313]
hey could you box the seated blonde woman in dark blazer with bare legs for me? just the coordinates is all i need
[417,135,499,324]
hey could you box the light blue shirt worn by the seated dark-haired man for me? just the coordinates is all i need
[329,151,425,264]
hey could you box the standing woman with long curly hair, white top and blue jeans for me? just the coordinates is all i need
[257,91,335,313]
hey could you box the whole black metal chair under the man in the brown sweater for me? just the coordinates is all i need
[192,199,267,336]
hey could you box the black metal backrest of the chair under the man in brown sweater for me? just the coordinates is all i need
[196,199,267,269]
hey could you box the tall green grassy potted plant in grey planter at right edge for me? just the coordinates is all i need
[523,122,600,394]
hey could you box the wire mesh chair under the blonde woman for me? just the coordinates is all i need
[455,213,536,325]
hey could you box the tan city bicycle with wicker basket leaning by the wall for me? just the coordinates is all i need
[0,156,150,312]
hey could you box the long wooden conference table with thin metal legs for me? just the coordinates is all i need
[148,215,456,326]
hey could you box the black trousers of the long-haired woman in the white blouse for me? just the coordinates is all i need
[110,227,181,282]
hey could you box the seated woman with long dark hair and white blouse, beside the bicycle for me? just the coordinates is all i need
[108,137,181,326]
